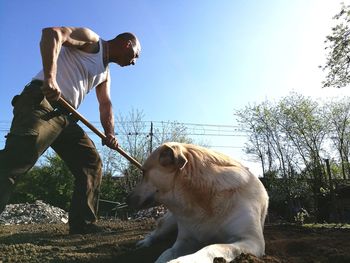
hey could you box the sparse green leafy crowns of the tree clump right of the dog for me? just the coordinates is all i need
[236,93,328,178]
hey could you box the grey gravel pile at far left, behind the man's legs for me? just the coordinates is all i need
[0,200,68,225]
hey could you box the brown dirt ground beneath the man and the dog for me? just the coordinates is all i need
[0,219,350,263]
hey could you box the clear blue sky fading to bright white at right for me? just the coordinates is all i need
[0,0,350,175]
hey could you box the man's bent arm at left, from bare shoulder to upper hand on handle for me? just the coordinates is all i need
[40,27,99,101]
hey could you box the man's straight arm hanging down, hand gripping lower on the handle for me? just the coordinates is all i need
[96,73,118,149]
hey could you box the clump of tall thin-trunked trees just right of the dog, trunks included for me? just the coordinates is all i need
[237,93,329,222]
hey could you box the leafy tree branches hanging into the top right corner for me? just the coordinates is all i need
[322,4,350,88]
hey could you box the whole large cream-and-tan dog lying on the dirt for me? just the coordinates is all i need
[128,143,268,263]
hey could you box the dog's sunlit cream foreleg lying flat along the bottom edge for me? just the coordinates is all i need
[169,240,264,263]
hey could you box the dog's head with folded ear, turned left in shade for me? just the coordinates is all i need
[127,143,187,209]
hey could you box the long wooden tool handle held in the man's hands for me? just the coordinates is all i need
[58,97,142,170]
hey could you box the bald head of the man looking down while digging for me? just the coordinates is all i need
[109,32,141,67]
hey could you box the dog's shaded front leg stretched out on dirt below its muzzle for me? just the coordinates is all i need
[136,211,177,248]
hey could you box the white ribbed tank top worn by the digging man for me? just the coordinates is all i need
[33,39,109,109]
